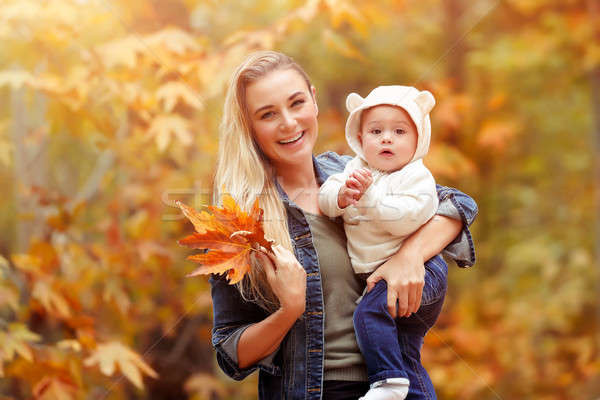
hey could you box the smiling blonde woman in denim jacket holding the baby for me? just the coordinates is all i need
[210,52,477,399]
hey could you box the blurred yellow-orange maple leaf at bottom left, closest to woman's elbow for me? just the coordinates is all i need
[83,342,158,389]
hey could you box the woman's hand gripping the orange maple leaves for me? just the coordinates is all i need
[256,245,306,318]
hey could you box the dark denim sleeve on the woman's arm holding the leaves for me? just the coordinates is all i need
[209,275,280,380]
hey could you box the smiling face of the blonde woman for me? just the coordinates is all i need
[246,68,318,169]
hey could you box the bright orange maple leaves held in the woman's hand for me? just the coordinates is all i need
[177,195,273,285]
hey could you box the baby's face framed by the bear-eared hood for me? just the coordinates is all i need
[359,105,418,172]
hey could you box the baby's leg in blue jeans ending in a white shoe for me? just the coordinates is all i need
[354,280,409,400]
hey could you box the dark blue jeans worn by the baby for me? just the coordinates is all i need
[354,255,448,400]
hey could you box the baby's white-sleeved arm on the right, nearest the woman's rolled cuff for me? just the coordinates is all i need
[376,167,438,236]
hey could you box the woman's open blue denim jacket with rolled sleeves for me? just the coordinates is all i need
[209,152,477,400]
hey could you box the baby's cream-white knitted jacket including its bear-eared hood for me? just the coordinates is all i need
[319,86,438,273]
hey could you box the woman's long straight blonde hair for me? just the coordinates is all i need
[213,51,312,311]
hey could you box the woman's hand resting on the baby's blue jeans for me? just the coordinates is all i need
[367,246,425,318]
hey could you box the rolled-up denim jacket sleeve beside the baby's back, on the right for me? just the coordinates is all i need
[437,185,478,267]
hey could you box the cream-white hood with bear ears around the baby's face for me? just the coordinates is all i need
[346,85,435,162]
